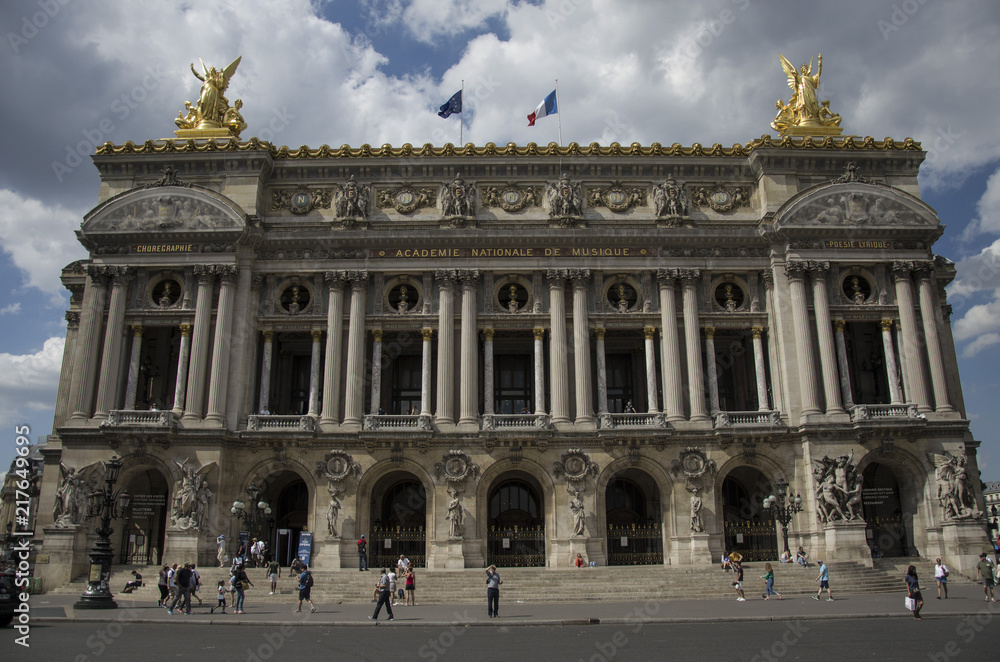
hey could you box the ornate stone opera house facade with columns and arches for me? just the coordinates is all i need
[38,131,985,585]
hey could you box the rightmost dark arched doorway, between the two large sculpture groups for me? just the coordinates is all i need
[861,462,912,558]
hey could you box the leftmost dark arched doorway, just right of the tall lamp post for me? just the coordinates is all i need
[118,468,169,565]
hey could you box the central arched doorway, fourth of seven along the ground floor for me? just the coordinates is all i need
[486,472,545,567]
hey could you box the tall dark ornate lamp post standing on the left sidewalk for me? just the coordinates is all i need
[73,457,131,609]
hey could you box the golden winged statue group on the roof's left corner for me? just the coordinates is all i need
[174,56,247,138]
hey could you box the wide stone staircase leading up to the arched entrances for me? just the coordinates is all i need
[51,559,971,604]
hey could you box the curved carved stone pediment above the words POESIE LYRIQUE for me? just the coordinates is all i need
[774,182,940,228]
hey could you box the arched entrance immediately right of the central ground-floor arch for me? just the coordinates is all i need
[604,469,663,565]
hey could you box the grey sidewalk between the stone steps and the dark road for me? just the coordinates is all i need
[23,581,1000,627]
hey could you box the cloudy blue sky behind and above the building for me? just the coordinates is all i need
[0,0,1000,480]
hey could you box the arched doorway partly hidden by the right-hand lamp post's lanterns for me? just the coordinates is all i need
[722,467,778,561]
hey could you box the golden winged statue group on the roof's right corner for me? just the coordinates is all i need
[771,53,843,136]
